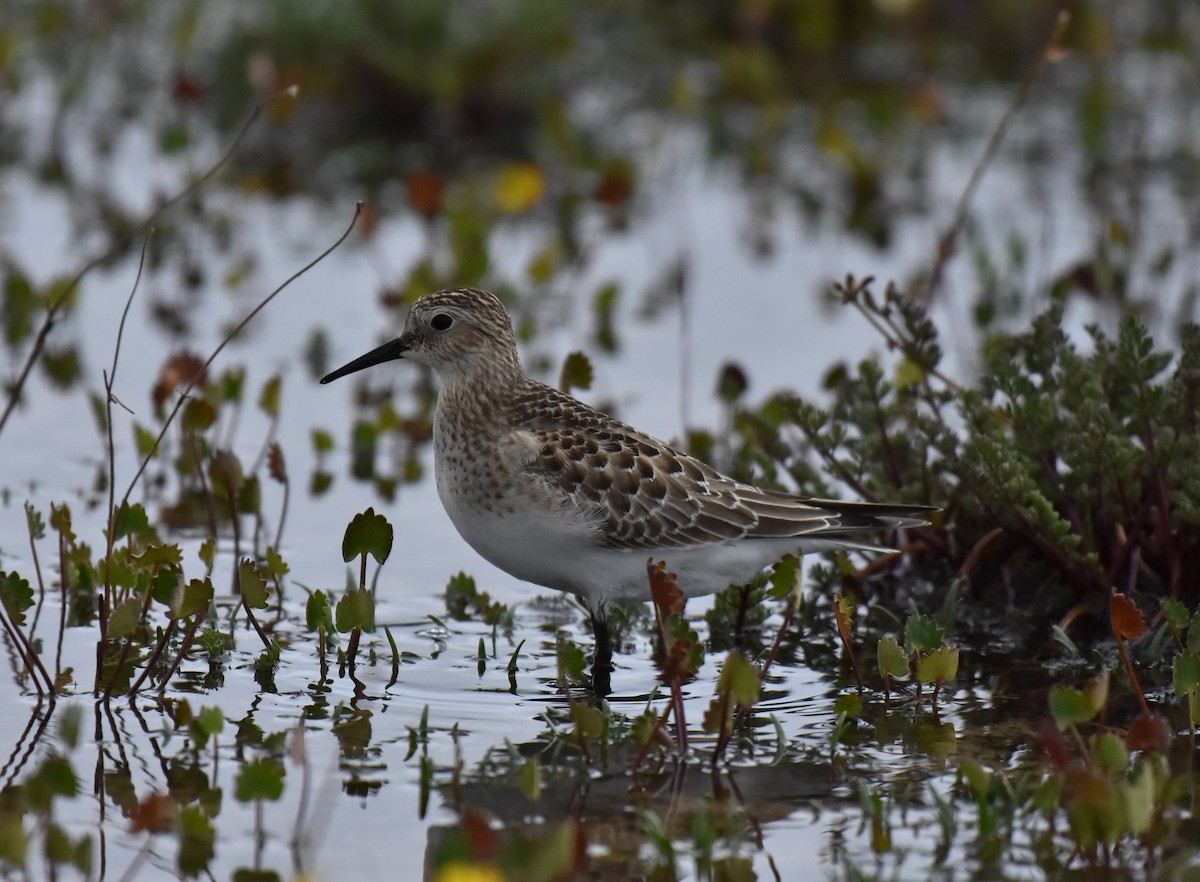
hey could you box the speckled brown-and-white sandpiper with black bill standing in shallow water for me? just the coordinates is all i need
[320,288,937,696]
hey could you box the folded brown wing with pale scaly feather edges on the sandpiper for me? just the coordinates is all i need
[514,386,840,548]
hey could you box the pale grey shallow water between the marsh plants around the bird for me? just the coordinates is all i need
[0,6,1188,880]
